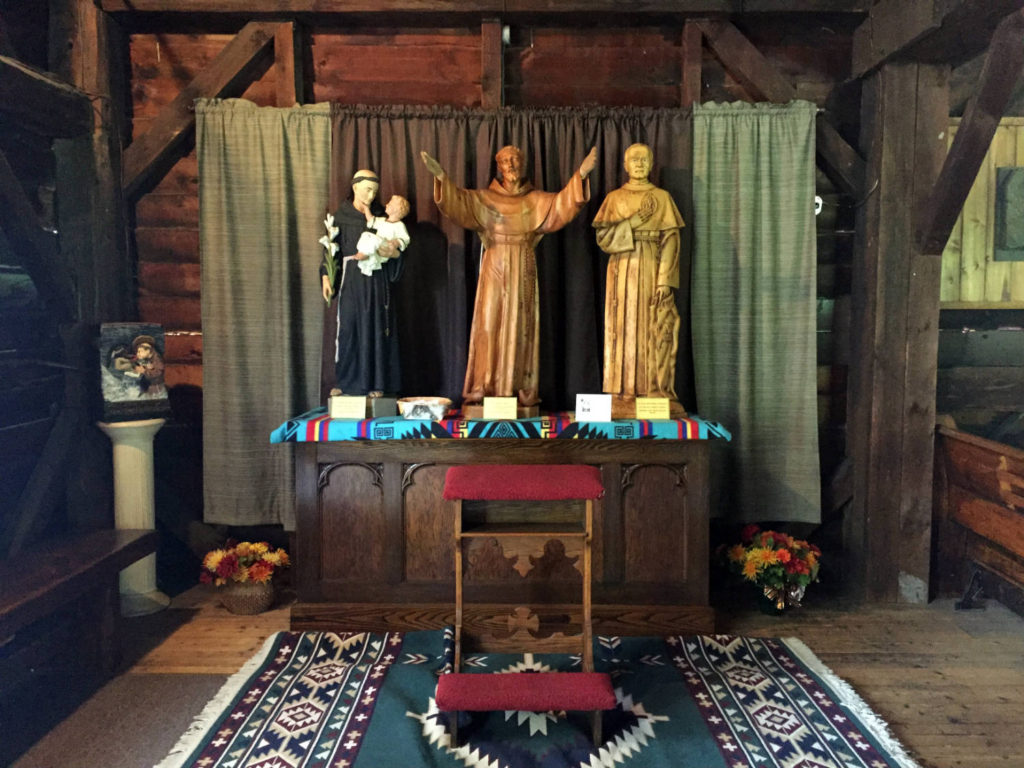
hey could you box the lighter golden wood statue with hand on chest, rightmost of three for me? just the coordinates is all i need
[594,144,686,418]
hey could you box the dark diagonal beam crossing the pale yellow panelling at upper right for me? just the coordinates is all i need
[918,10,1024,254]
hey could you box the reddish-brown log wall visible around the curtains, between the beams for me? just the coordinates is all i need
[130,13,861,518]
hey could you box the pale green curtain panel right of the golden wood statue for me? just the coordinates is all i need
[691,101,821,523]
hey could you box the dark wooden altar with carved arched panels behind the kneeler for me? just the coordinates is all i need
[291,415,714,637]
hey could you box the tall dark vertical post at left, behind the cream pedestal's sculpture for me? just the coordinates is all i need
[50,0,136,529]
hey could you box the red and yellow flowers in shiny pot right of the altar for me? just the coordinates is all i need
[725,525,821,610]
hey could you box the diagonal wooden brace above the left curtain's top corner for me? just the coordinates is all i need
[124,22,279,198]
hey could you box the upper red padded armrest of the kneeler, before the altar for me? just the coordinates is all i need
[444,464,604,502]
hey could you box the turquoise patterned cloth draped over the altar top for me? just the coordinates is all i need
[270,408,732,442]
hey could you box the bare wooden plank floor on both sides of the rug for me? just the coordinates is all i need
[121,587,1024,768]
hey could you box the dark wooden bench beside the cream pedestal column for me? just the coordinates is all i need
[0,529,159,687]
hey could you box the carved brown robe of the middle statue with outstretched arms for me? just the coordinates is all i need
[434,171,590,406]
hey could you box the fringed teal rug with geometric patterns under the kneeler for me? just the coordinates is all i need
[158,631,916,768]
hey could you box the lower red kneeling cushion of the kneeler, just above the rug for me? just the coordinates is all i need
[436,672,615,712]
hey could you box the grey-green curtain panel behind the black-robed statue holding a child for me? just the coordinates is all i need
[196,99,331,529]
